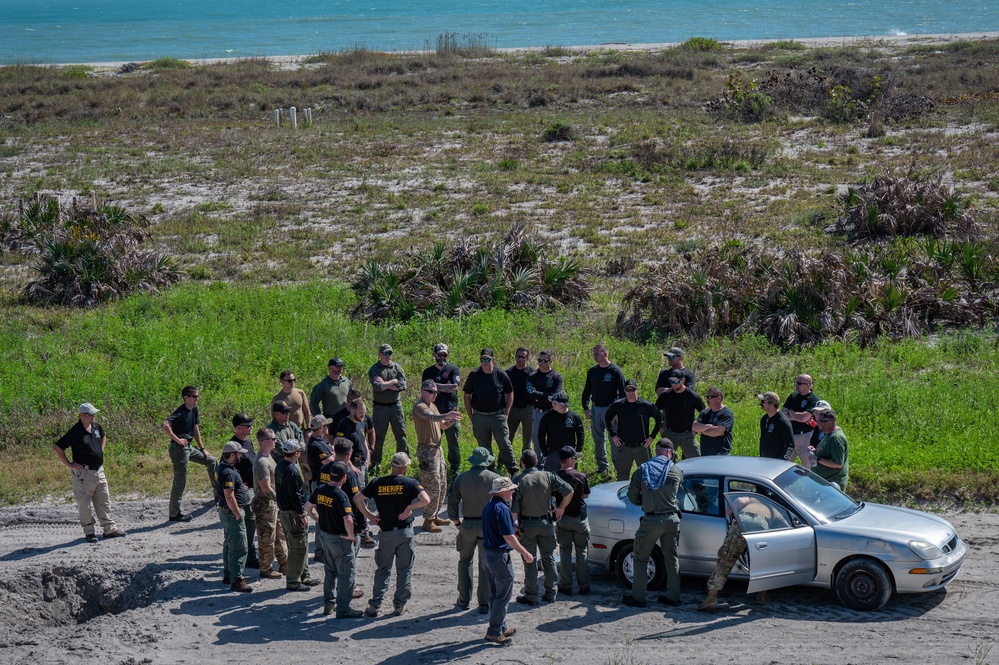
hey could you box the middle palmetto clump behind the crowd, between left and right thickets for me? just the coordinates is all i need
[352,224,590,321]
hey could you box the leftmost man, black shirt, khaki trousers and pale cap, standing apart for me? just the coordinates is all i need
[52,402,125,543]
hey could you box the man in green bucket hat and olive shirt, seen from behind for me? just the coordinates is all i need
[447,448,500,614]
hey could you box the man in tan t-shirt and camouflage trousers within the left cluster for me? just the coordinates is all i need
[250,428,288,579]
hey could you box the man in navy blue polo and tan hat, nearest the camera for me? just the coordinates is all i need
[482,476,534,646]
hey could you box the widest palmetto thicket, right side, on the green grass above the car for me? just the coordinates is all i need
[617,238,999,347]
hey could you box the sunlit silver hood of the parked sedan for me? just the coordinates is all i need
[825,503,957,547]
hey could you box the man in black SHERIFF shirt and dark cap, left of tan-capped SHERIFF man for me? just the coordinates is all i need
[305,462,361,619]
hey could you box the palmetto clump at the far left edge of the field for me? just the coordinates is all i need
[0,196,180,307]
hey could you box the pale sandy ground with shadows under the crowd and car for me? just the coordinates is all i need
[0,498,999,665]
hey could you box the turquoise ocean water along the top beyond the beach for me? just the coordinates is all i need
[0,0,999,63]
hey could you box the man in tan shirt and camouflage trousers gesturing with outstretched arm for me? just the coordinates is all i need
[413,379,461,533]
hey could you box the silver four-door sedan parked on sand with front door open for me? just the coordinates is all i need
[586,456,967,610]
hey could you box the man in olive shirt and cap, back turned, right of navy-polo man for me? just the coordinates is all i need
[510,450,573,605]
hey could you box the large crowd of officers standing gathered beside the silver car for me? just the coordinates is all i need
[54,343,848,644]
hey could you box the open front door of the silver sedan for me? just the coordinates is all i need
[725,492,816,593]
